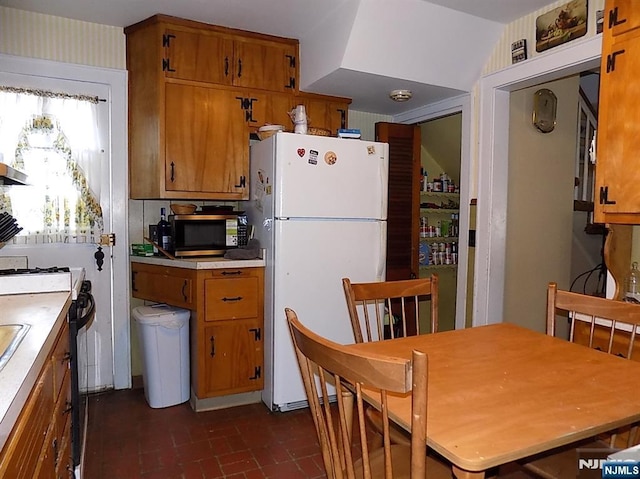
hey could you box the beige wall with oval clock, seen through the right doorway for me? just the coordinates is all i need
[504,75,580,332]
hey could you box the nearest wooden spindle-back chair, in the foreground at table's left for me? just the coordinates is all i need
[285,308,452,479]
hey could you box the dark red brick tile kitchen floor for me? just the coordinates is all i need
[83,389,529,479]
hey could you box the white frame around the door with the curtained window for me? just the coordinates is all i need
[0,54,131,389]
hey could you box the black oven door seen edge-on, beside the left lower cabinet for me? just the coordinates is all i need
[69,281,96,479]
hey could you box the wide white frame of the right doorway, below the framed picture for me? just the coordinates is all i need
[473,35,602,326]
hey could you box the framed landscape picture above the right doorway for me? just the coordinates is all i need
[536,0,588,52]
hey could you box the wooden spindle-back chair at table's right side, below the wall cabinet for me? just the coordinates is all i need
[521,283,640,479]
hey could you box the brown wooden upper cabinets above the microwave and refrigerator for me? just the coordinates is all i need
[124,15,351,201]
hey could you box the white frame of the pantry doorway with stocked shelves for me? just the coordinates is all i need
[393,94,476,329]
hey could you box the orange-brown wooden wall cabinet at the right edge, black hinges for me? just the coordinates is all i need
[594,0,640,224]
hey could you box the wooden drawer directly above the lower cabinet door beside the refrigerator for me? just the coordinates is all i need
[205,277,258,321]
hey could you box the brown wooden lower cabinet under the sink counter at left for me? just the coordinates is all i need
[0,323,73,479]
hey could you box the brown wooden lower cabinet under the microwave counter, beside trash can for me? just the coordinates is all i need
[131,262,264,399]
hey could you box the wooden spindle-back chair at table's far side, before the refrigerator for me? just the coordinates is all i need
[342,274,438,343]
